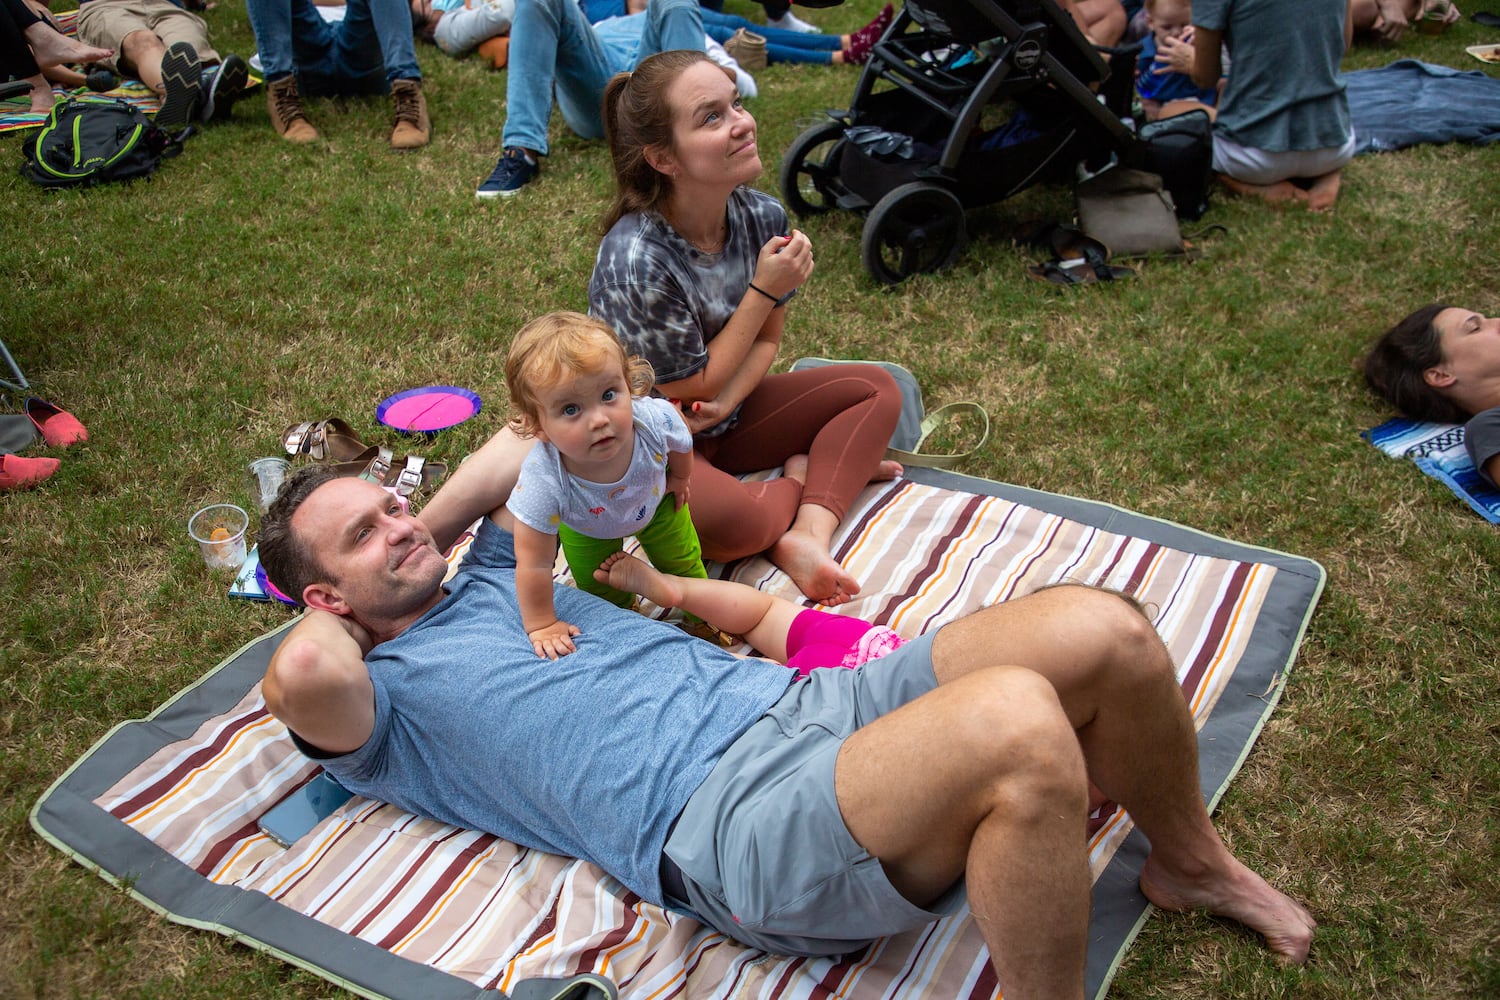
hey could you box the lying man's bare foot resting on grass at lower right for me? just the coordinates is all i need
[1140,855,1317,966]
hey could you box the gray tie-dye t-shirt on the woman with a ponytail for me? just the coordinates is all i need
[588,187,788,392]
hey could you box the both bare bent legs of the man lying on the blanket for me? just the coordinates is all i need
[836,586,1316,997]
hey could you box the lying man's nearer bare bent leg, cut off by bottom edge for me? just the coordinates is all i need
[834,667,1089,1000]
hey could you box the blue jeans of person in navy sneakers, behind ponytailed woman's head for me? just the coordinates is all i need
[498,0,704,154]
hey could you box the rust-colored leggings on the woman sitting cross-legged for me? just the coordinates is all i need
[692,364,902,562]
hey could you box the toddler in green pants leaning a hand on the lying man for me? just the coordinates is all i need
[506,312,717,660]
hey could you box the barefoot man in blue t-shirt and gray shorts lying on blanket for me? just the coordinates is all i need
[260,432,1314,997]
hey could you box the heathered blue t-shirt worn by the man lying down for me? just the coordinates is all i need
[312,519,797,903]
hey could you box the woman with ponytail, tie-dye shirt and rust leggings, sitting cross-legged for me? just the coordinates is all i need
[588,51,902,604]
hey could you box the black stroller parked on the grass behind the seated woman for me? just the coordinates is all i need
[780,0,1142,285]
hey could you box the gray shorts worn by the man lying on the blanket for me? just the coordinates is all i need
[663,634,963,955]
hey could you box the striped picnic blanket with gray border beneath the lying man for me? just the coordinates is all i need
[33,469,1323,1000]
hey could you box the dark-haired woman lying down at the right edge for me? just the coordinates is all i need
[1365,303,1500,487]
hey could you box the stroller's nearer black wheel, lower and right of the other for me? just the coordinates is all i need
[863,181,968,285]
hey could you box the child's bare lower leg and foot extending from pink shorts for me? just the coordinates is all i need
[594,552,803,663]
